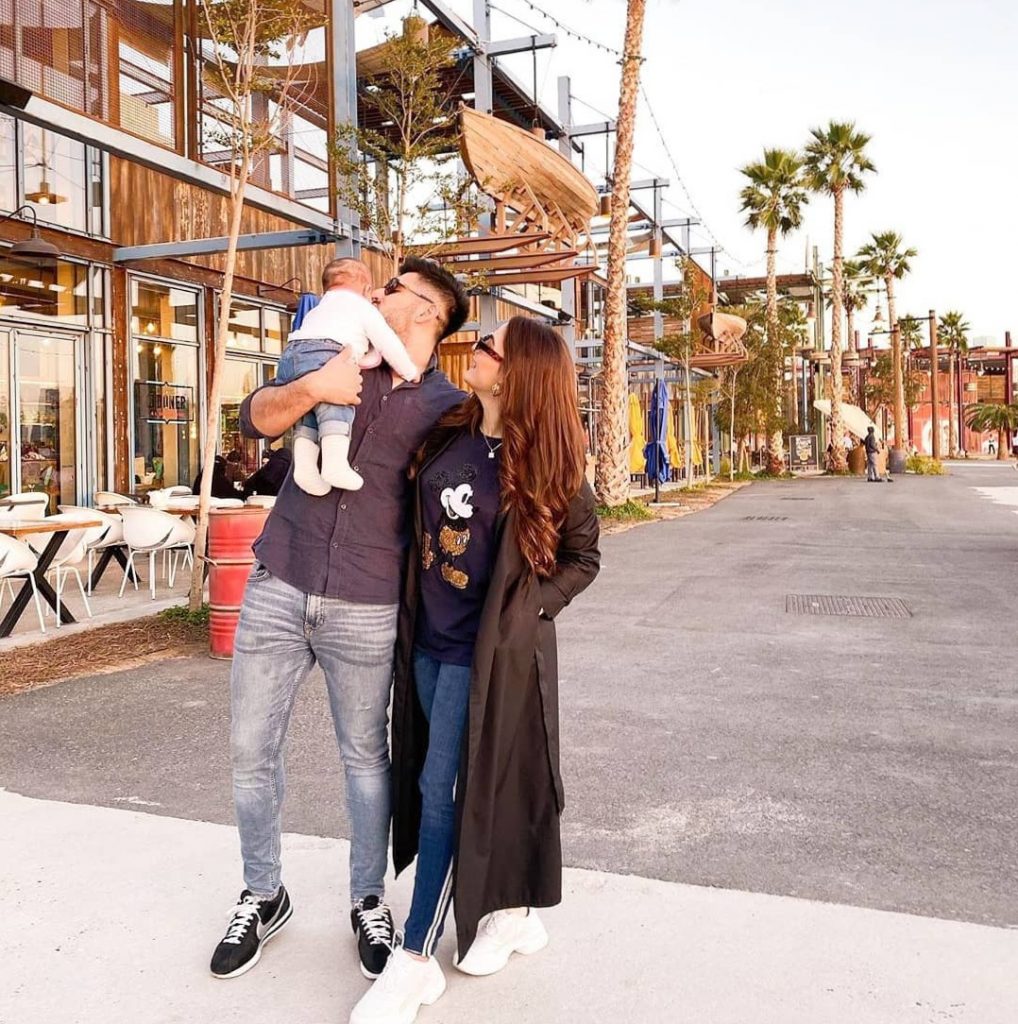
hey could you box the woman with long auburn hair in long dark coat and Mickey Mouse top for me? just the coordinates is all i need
[350,316,599,1024]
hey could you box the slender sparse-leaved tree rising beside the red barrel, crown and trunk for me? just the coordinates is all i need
[189,0,324,610]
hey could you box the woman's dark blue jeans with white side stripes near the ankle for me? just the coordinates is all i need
[402,648,470,956]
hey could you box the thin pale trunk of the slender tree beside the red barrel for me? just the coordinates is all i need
[187,154,251,611]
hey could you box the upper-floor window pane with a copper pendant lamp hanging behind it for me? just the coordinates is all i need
[22,122,88,231]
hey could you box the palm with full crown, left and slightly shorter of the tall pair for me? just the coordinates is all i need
[739,150,809,473]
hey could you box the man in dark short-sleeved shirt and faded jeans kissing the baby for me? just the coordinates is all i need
[211,258,468,978]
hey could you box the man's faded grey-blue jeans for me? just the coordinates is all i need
[230,565,397,902]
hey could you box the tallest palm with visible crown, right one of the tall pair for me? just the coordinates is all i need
[806,121,876,473]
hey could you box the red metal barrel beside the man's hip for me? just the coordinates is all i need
[209,506,269,658]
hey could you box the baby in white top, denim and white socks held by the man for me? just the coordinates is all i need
[275,259,421,495]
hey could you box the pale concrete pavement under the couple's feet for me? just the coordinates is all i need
[0,791,1018,1024]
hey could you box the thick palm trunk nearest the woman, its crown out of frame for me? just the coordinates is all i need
[594,0,647,507]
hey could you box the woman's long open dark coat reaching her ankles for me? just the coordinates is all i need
[392,442,600,955]
